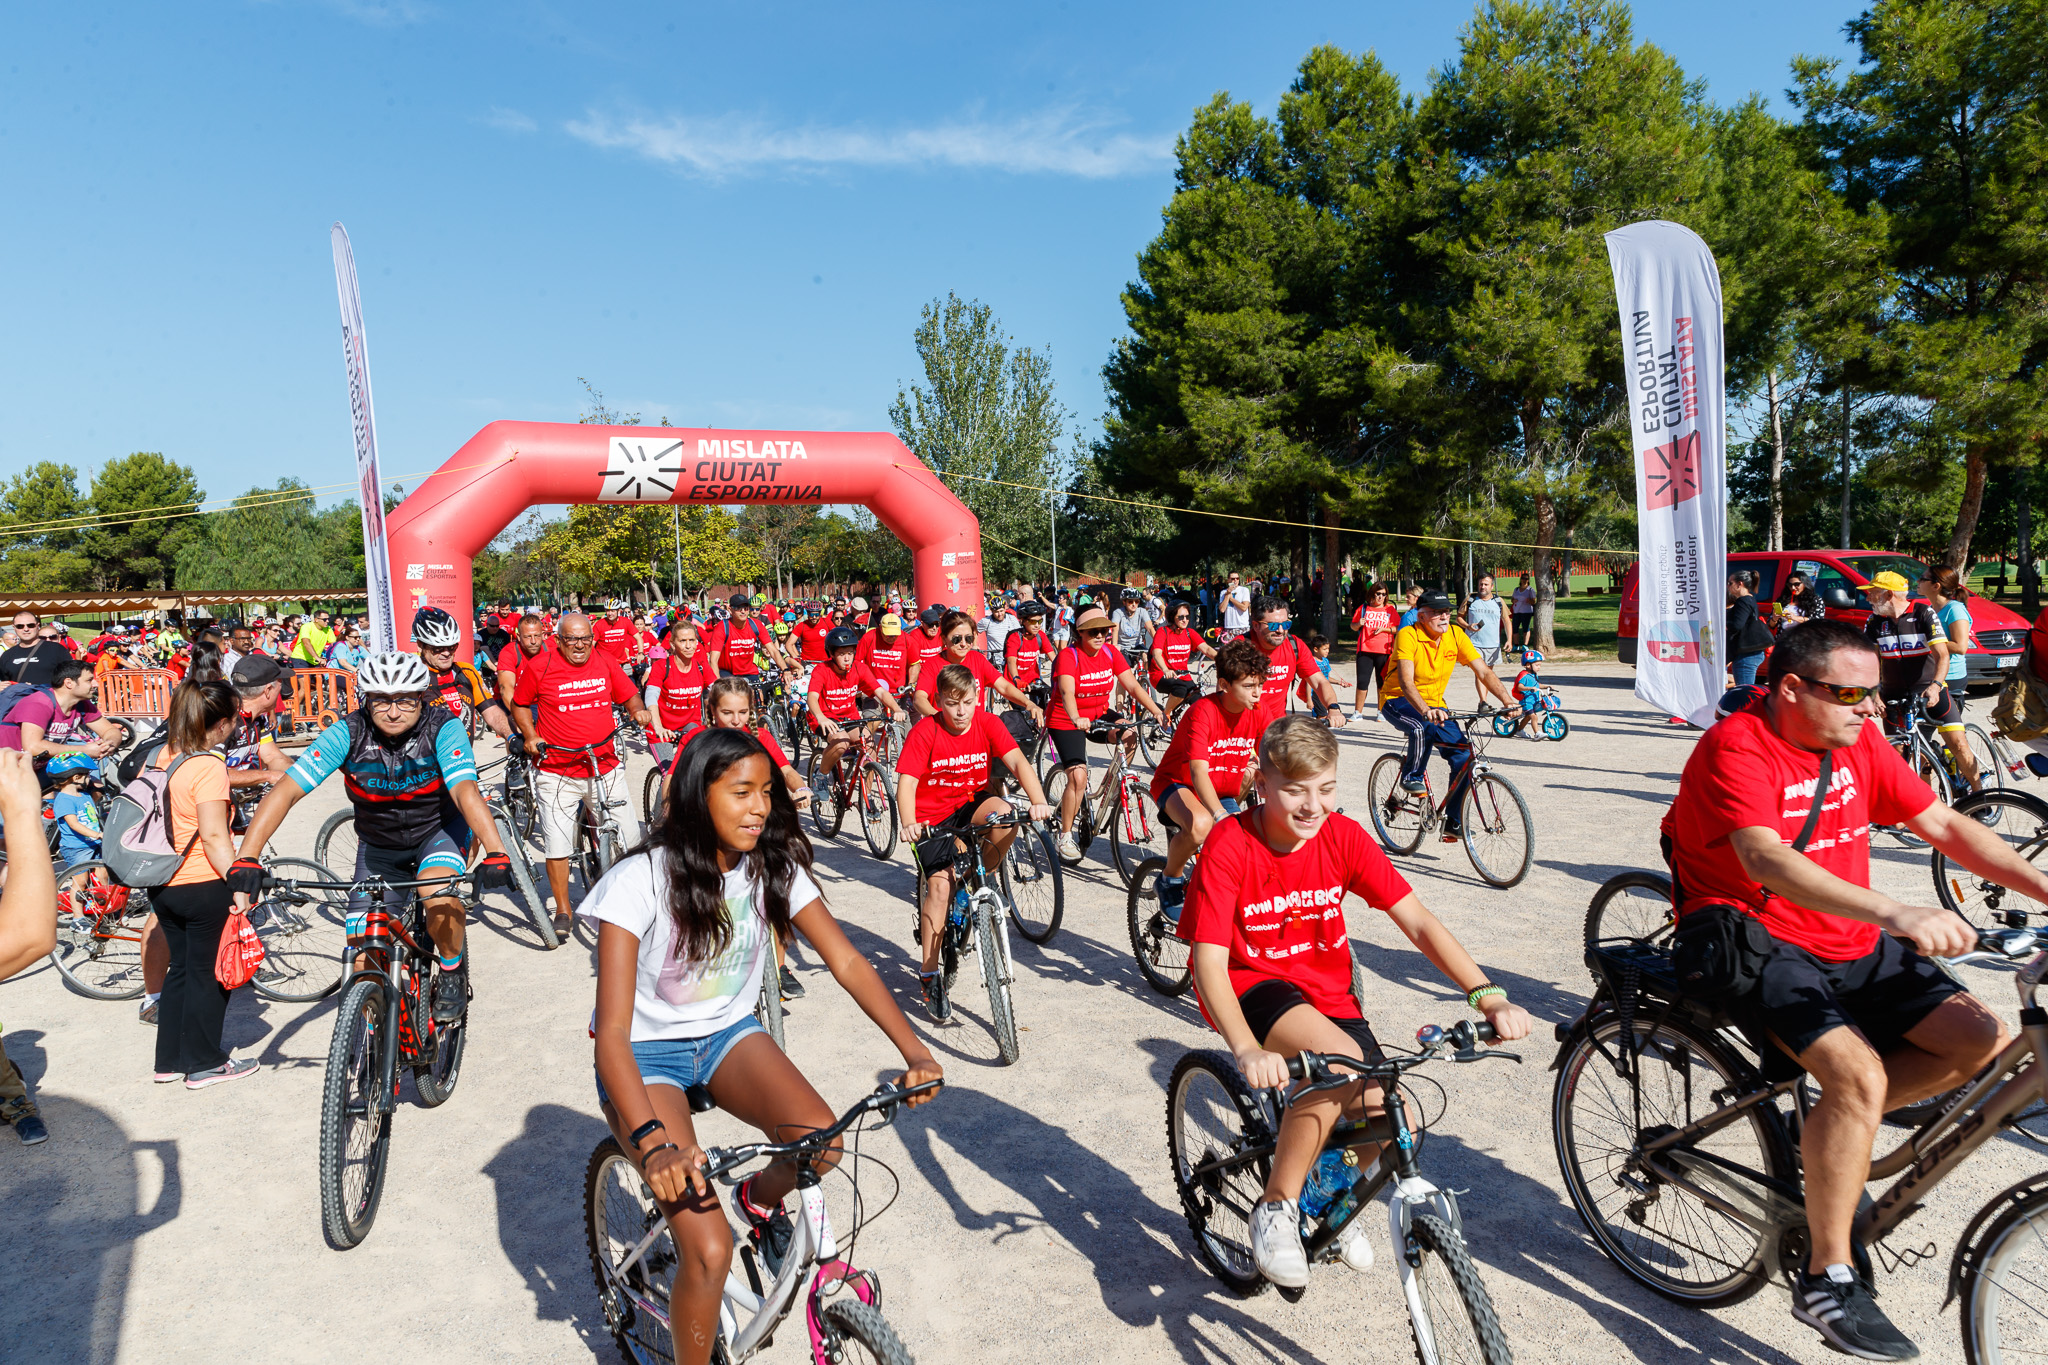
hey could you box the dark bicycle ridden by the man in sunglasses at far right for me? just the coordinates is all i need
[1550,874,2048,1365]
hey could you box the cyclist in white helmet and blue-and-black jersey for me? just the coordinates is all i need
[227,655,512,1023]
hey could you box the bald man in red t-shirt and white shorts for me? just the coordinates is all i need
[512,612,668,937]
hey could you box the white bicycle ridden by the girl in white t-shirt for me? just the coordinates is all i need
[584,1081,940,1365]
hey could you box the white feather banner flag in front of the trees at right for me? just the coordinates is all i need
[1608,221,1729,726]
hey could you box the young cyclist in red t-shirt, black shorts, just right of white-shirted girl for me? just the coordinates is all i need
[897,655,1053,1023]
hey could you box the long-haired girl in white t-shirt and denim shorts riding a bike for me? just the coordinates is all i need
[578,731,940,1365]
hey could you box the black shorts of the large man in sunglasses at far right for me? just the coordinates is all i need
[1729,933,1964,1056]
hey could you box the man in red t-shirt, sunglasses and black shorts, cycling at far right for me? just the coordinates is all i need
[1669,620,2048,1359]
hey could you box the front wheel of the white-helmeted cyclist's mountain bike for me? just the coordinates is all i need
[319,980,391,1250]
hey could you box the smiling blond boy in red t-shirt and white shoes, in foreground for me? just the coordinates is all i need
[1182,716,1530,1289]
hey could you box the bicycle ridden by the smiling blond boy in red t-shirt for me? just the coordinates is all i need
[1165,1019,1522,1365]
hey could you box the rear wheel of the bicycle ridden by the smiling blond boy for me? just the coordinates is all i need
[1165,1050,1274,1297]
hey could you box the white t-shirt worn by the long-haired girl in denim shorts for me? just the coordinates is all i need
[575,849,819,1042]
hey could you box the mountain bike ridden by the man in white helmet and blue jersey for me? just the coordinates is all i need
[299,874,475,1250]
